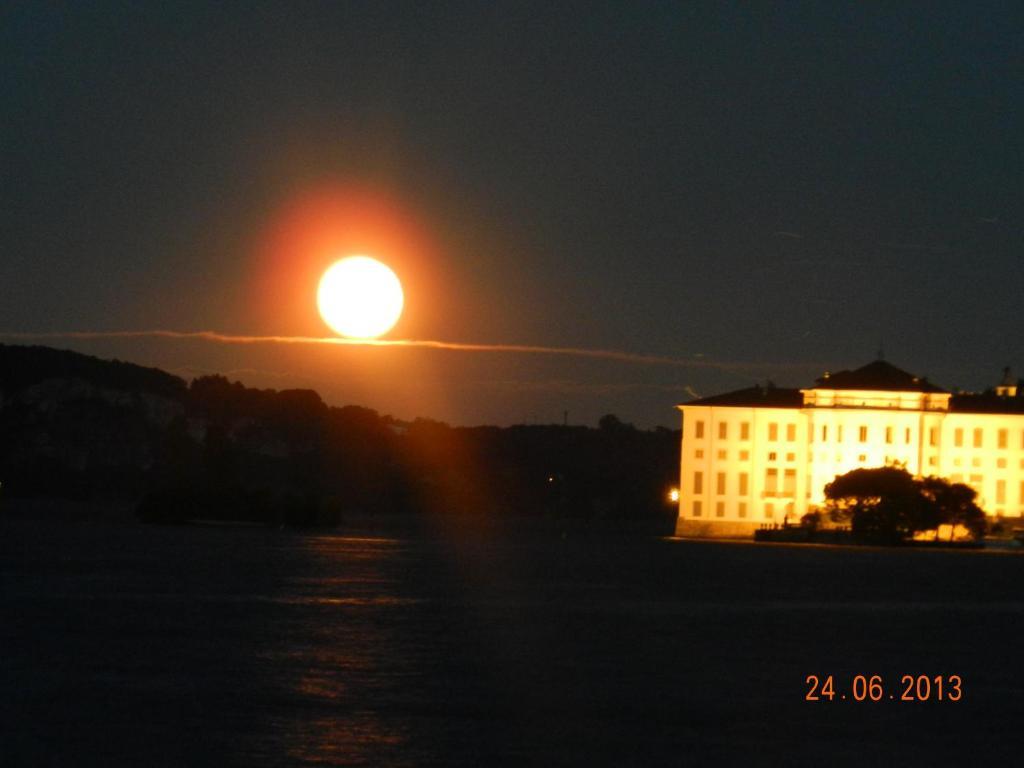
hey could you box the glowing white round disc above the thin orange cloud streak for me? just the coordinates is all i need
[316,256,404,339]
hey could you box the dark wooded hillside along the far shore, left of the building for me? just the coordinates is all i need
[0,345,679,528]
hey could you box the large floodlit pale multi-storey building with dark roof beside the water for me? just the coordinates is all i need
[676,360,1024,537]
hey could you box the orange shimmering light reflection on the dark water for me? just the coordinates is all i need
[266,537,422,765]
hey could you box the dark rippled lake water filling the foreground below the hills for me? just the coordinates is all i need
[0,521,1024,766]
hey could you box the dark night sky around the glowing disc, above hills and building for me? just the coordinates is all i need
[0,2,1024,426]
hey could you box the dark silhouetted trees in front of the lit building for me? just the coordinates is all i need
[825,467,985,544]
